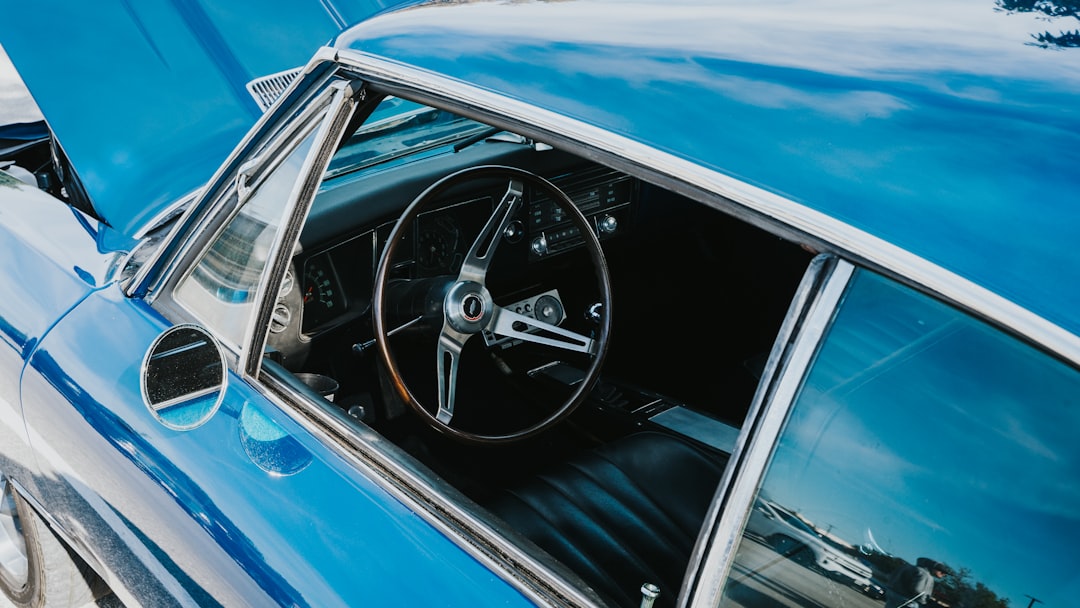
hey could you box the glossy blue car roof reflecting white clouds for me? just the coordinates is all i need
[337,0,1080,343]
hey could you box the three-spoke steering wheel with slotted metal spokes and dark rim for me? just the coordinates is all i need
[373,165,611,444]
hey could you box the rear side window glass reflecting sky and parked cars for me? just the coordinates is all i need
[720,271,1080,608]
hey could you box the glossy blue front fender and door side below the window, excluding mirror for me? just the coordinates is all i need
[0,156,527,607]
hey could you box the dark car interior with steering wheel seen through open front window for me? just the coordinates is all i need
[265,92,813,606]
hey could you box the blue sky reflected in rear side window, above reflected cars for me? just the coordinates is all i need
[764,272,1080,606]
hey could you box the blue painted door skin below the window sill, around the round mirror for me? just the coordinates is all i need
[23,285,527,607]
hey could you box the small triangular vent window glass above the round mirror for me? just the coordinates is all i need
[175,126,318,347]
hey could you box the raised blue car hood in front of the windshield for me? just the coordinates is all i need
[0,0,408,237]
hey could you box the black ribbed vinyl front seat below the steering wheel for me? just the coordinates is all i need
[488,431,727,607]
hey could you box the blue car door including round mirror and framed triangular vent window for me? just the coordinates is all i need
[23,73,533,606]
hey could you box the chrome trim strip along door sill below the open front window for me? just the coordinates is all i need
[252,369,600,608]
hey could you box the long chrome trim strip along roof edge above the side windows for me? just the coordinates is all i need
[338,49,1080,365]
